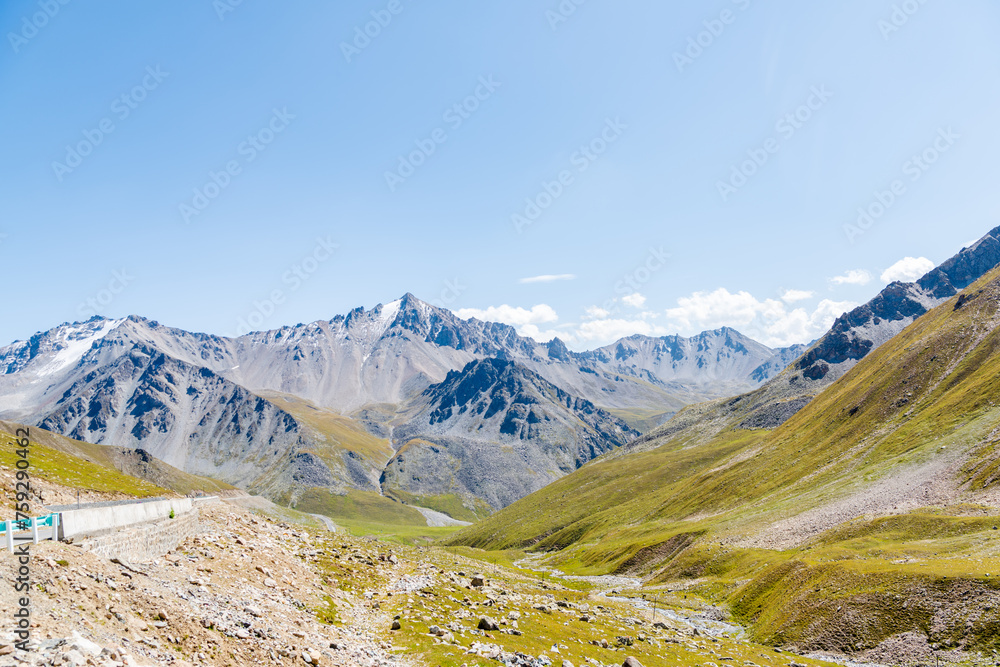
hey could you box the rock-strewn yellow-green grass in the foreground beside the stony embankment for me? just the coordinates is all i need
[317,537,836,667]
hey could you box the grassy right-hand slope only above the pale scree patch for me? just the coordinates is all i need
[456,270,1000,546]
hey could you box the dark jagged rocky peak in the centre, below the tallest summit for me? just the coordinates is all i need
[382,359,638,508]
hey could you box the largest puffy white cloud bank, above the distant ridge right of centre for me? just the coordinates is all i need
[667,288,857,346]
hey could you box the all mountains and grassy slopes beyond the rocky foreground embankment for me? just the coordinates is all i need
[0,223,1000,664]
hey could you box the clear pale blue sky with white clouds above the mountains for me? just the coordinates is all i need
[0,0,1000,349]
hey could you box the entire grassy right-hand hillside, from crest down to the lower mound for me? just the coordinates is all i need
[449,270,1000,650]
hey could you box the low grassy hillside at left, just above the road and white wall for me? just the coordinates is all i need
[0,421,235,495]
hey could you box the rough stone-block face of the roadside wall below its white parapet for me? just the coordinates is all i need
[79,509,200,563]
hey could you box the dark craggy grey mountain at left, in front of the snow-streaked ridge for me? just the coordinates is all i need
[28,345,378,498]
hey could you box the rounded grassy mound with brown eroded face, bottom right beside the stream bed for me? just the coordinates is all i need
[713,513,1000,651]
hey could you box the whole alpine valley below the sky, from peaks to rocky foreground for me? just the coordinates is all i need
[0,227,1000,667]
